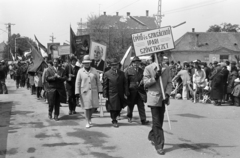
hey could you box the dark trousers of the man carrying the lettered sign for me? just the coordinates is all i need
[148,103,165,150]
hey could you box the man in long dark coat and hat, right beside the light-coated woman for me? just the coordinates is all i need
[103,58,128,128]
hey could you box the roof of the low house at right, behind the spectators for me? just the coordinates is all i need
[171,32,240,51]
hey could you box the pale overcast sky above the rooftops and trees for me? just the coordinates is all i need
[0,0,240,46]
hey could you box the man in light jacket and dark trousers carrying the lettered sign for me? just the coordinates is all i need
[143,52,172,155]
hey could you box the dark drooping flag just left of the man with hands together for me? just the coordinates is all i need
[29,43,43,72]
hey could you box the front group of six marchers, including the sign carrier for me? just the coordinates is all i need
[15,52,172,155]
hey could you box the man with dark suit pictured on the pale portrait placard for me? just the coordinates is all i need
[91,46,105,72]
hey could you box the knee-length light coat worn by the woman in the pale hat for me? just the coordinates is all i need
[75,67,102,109]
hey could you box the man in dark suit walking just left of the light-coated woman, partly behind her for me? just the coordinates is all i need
[65,56,79,115]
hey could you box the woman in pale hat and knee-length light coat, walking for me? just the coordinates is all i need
[75,55,102,128]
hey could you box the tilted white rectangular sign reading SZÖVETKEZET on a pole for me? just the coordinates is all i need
[132,26,175,56]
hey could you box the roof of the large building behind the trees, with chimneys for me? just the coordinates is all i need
[99,15,157,29]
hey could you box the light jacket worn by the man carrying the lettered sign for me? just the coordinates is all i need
[143,63,172,107]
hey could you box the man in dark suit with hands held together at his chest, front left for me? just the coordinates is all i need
[45,59,66,121]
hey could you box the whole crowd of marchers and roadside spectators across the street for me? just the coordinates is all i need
[0,52,240,155]
